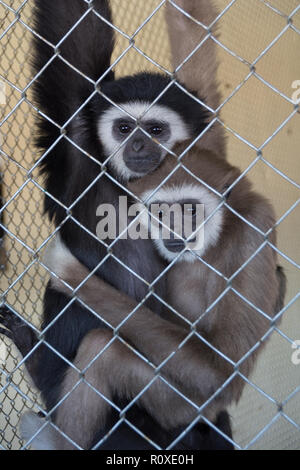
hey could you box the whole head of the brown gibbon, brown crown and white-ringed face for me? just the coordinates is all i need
[128,144,243,262]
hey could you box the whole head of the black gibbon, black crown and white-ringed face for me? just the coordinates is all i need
[96,73,207,181]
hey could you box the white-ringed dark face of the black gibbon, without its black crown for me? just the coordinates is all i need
[98,102,190,180]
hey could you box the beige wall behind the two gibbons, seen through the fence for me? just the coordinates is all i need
[0,0,300,449]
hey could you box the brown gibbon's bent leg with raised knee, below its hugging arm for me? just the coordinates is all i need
[47,329,206,450]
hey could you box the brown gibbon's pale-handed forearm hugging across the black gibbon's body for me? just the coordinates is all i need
[45,242,237,399]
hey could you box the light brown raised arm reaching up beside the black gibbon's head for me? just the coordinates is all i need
[166,0,226,157]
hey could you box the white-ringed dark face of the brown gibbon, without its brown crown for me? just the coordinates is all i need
[137,184,224,262]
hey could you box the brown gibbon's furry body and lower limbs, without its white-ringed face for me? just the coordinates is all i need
[46,148,279,447]
